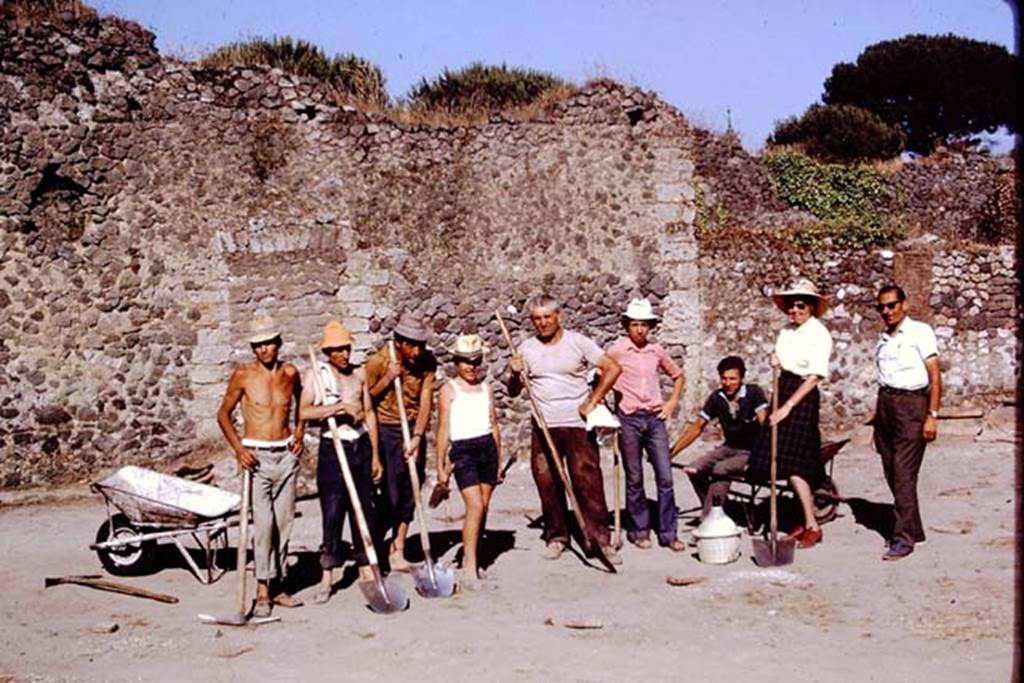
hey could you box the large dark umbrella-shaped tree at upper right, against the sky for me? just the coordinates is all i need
[821,34,1020,154]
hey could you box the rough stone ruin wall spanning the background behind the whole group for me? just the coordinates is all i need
[0,13,1016,487]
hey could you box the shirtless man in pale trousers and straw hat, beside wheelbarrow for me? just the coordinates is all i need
[217,317,303,616]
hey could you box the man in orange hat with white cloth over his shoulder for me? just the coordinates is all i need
[299,321,383,604]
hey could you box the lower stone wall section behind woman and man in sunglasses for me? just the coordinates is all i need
[700,239,1020,432]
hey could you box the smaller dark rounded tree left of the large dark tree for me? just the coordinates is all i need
[768,104,904,162]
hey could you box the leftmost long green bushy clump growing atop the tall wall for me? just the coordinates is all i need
[201,36,388,108]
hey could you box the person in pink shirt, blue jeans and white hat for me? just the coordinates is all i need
[607,299,686,552]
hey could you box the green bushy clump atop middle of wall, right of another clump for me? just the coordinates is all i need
[409,62,569,113]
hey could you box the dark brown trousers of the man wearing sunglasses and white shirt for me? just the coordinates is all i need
[874,392,928,546]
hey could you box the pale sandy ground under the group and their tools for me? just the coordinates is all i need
[0,436,1014,683]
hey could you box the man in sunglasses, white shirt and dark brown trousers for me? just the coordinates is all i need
[873,285,942,561]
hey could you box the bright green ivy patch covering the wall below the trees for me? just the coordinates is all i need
[763,151,904,249]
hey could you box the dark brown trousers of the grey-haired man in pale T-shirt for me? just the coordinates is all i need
[530,424,611,546]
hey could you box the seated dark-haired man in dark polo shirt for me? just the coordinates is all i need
[672,355,768,517]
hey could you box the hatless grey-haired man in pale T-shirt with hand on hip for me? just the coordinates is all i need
[506,296,622,563]
